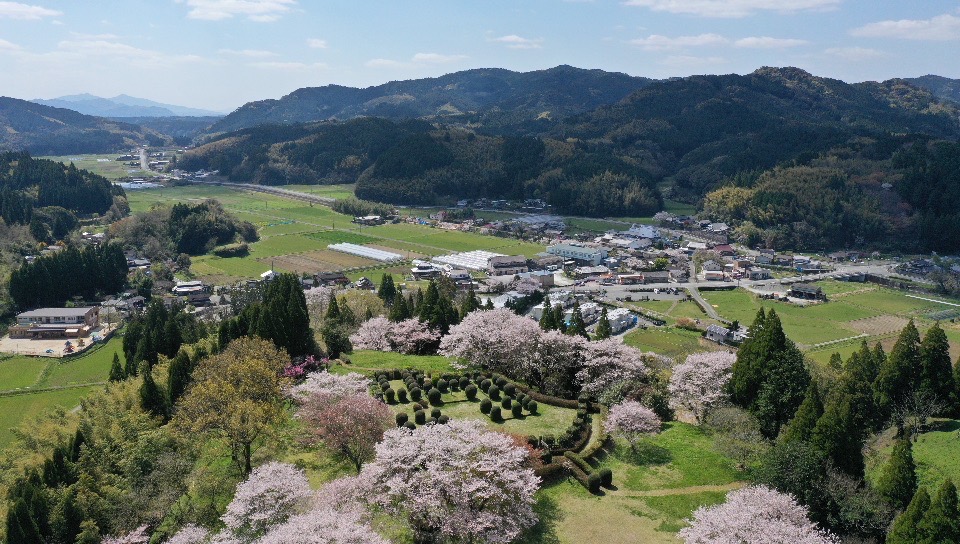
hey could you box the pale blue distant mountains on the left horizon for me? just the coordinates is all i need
[31,93,223,118]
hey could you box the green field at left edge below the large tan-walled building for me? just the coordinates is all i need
[0,335,123,449]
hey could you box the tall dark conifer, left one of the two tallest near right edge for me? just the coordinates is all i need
[874,319,921,419]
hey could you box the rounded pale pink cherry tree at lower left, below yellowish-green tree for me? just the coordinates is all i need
[222,462,312,540]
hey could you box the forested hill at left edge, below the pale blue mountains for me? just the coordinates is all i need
[0,97,170,155]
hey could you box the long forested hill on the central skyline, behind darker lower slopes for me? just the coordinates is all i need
[202,66,652,133]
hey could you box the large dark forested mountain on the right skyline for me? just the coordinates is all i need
[551,68,960,202]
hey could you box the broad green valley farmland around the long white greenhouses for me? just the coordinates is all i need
[128,185,545,283]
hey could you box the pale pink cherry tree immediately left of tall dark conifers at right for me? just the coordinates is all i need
[669,351,737,424]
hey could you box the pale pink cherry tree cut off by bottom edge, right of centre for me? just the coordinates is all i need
[678,486,839,544]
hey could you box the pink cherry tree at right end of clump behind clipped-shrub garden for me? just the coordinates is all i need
[577,338,669,403]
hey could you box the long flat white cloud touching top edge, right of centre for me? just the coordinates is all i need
[624,0,842,17]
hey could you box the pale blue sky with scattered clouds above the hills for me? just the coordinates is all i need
[0,0,960,111]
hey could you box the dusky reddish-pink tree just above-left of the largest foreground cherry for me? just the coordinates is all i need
[297,393,395,472]
